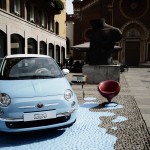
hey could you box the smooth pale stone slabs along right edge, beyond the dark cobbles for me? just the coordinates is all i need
[123,68,150,133]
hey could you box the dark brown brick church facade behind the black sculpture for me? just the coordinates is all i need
[73,0,150,66]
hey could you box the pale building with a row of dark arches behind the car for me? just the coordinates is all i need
[0,0,66,63]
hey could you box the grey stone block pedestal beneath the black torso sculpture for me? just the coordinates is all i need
[82,65,120,84]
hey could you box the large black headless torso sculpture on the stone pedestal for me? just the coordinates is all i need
[89,18,122,65]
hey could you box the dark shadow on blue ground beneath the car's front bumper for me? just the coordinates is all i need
[0,129,65,148]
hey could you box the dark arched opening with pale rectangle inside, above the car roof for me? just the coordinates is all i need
[11,34,25,54]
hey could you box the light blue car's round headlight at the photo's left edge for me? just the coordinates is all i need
[0,93,11,107]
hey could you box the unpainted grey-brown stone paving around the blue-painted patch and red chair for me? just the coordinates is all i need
[66,68,150,150]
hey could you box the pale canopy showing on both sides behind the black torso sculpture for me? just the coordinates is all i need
[71,42,122,52]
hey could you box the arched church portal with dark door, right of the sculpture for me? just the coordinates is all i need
[122,22,147,66]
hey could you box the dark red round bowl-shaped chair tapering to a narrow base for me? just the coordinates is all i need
[97,80,120,103]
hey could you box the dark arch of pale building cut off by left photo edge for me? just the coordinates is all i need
[0,30,7,58]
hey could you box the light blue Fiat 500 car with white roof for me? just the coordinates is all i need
[0,54,78,132]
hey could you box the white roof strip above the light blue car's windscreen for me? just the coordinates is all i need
[6,54,50,58]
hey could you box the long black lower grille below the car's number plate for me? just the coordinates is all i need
[6,116,70,129]
